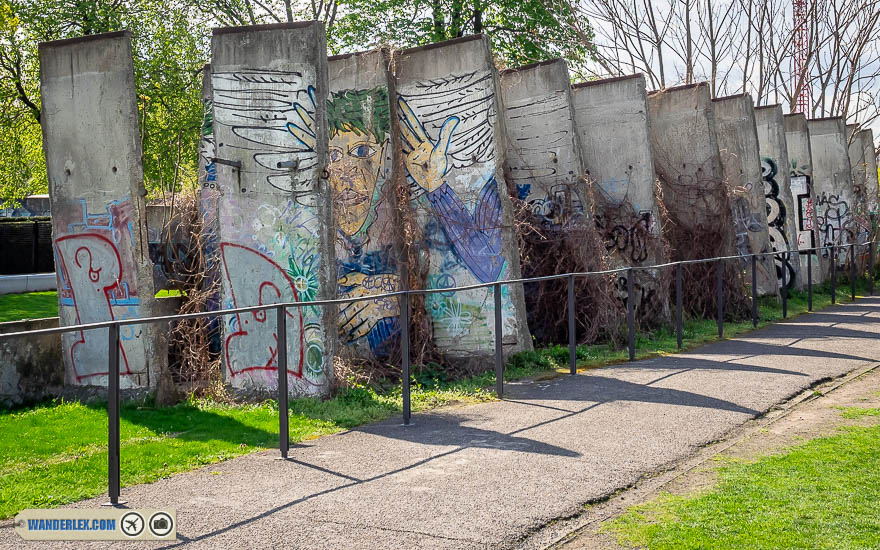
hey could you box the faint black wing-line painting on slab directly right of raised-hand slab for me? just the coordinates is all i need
[504,91,584,230]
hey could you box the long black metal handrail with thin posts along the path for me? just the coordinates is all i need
[0,240,876,506]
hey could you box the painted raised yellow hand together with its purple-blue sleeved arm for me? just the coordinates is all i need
[398,93,504,283]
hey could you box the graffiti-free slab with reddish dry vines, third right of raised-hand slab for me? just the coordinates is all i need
[648,82,735,260]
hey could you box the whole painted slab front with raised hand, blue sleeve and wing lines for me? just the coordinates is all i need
[398,71,515,351]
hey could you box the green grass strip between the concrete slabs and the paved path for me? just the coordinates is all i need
[0,280,872,518]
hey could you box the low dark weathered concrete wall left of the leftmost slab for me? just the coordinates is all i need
[0,317,64,407]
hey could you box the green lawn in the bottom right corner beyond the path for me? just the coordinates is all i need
[603,427,880,550]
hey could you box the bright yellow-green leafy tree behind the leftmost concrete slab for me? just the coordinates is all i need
[0,0,210,205]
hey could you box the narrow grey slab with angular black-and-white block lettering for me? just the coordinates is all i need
[784,113,829,283]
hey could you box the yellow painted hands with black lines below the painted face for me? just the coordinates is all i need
[338,272,400,342]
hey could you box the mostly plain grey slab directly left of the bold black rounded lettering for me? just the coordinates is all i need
[712,94,776,296]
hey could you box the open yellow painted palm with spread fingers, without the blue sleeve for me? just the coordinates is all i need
[397,98,459,192]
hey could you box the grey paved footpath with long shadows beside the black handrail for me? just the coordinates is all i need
[6,298,880,550]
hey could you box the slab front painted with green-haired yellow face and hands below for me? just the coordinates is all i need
[301,87,400,359]
